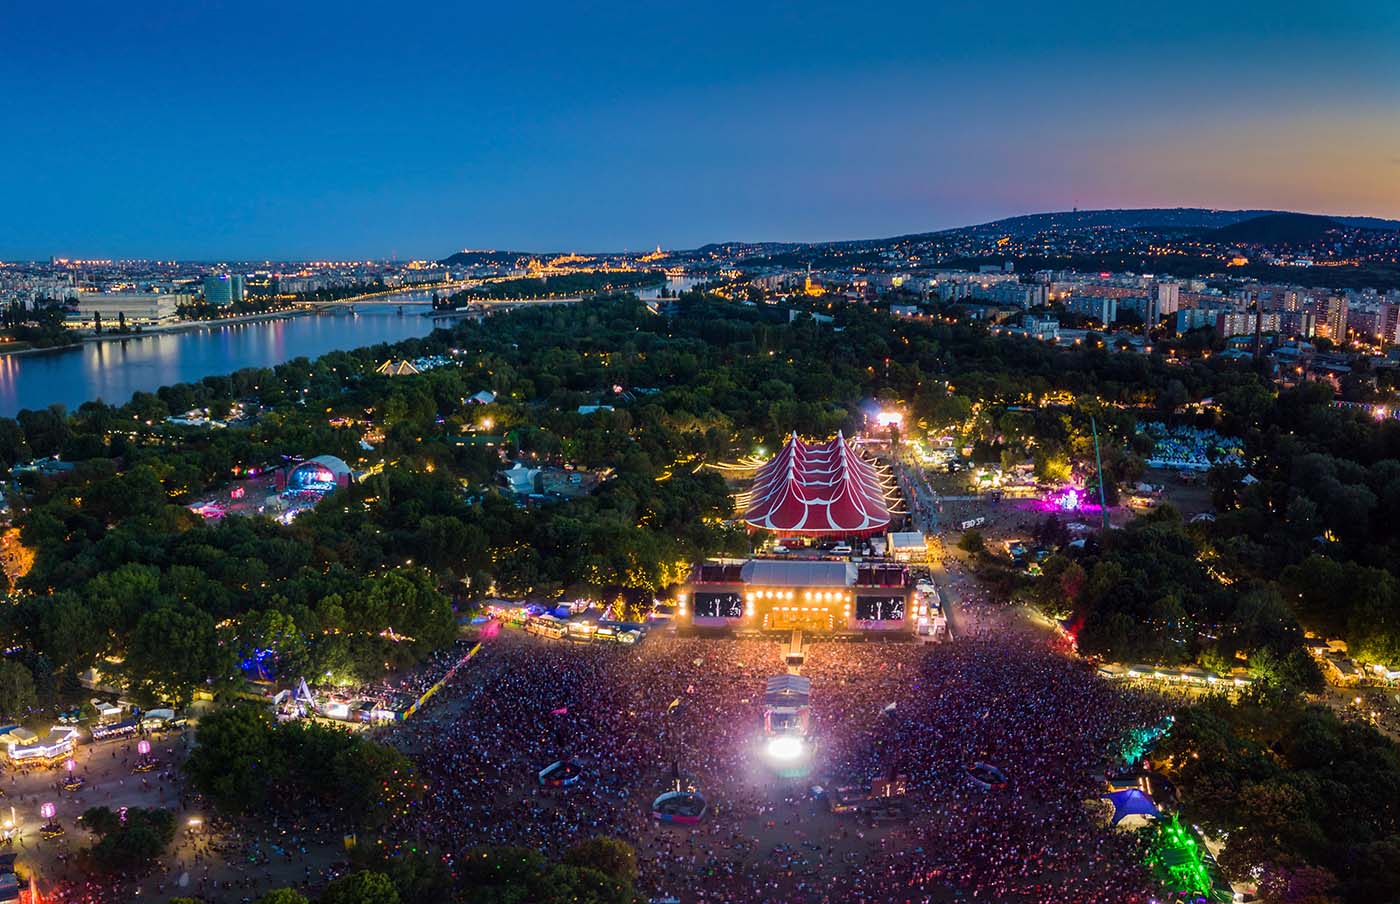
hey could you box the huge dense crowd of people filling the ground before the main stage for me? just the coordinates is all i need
[391,633,1168,904]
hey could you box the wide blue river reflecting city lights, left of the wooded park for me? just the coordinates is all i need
[0,292,434,417]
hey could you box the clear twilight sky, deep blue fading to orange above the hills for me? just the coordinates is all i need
[0,0,1400,259]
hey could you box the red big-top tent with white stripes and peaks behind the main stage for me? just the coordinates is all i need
[743,434,889,536]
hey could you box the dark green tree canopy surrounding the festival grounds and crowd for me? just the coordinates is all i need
[0,291,1400,903]
